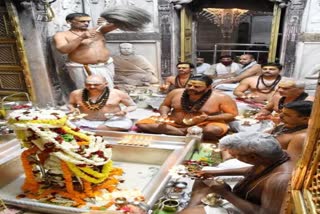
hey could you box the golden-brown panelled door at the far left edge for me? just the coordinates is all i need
[0,0,34,100]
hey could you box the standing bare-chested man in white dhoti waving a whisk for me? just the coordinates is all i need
[53,13,117,89]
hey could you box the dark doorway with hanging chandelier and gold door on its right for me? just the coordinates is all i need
[180,0,288,64]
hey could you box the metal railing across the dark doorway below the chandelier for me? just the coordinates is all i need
[197,43,269,64]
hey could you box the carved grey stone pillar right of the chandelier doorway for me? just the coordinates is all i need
[280,0,307,76]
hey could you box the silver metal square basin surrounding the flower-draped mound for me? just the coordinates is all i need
[0,132,197,214]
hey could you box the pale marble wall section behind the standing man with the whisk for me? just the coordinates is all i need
[13,0,176,105]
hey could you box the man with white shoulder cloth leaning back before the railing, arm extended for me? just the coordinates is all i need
[212,54,261,89]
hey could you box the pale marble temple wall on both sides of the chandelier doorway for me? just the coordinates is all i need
[13,0,320,102]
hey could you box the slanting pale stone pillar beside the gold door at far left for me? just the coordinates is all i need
[14,3,55,106]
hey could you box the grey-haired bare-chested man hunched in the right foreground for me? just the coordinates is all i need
[180,132,294,214]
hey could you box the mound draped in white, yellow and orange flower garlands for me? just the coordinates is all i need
[9,109,127,209]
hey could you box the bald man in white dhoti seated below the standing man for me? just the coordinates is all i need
[68,75,137,131]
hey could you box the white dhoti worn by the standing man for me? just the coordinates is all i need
[65,58,114,89]
